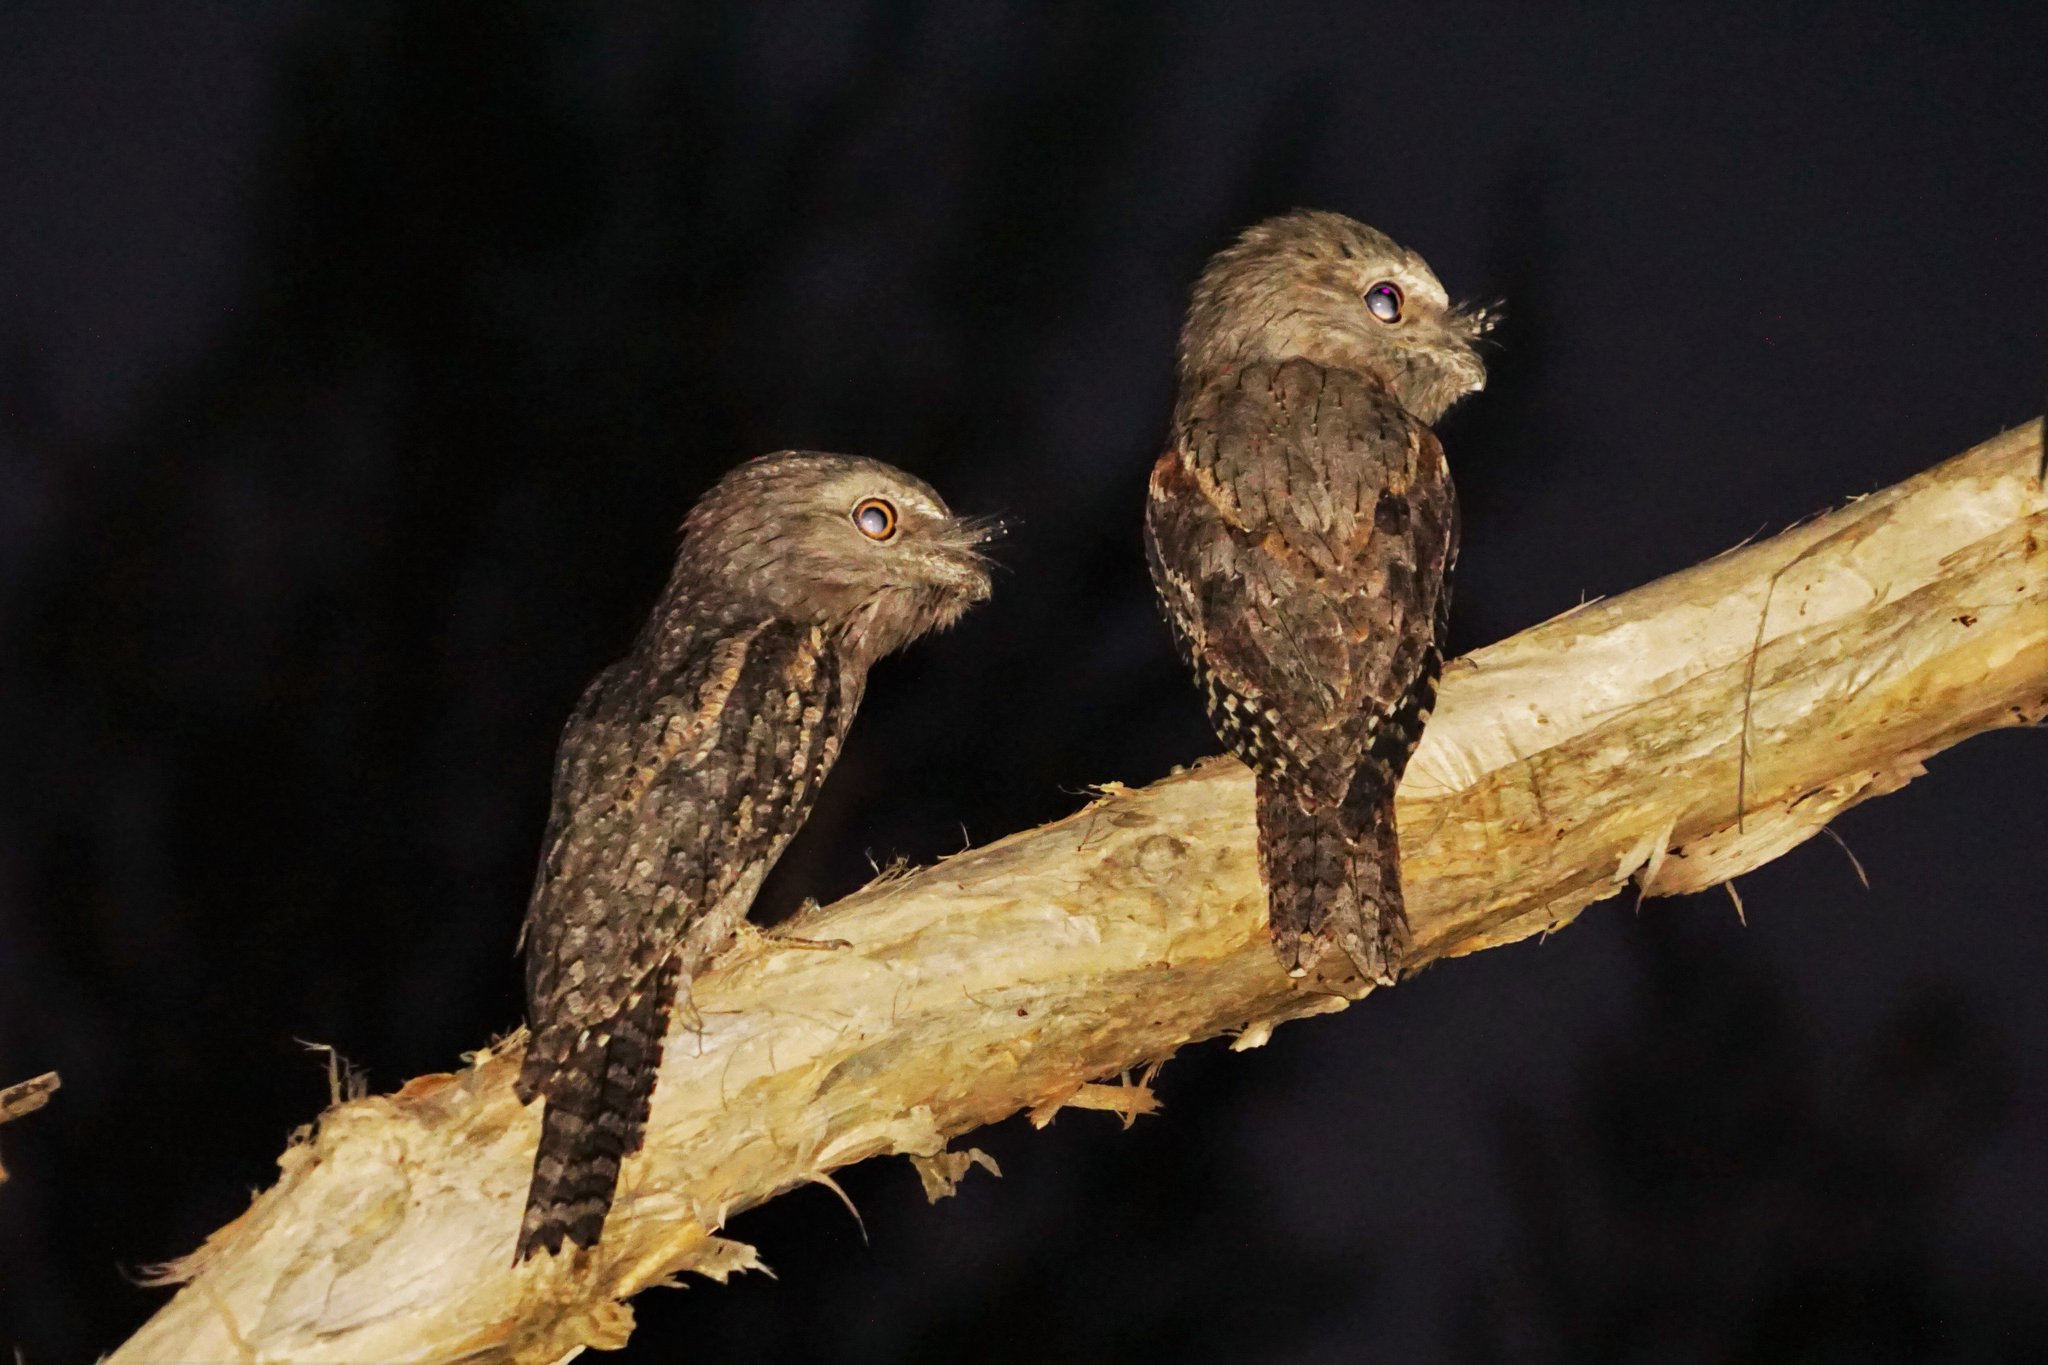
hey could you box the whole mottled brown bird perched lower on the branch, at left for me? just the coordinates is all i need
[518,450,991,1261]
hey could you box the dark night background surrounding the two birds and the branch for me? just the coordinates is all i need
[0,0,2048,1363]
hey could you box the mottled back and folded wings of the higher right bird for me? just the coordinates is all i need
[1147,360,1456,800]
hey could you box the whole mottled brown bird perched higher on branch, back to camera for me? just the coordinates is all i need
[1145,211,1489,990]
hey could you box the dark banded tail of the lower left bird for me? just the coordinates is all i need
[514,964,676,1263]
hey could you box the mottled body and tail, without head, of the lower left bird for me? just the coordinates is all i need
[516,622,858,1259]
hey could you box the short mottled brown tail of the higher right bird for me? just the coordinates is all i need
[1257,778,1409,986]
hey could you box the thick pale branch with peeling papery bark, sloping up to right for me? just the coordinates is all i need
[113,424,2048,1361]
